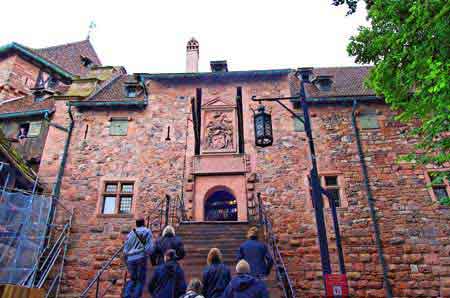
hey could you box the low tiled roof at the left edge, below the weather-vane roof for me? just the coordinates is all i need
[0,95,55,115]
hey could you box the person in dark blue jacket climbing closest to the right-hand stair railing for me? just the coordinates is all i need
[238,227,273,278]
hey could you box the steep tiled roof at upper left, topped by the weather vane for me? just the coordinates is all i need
[34,40,101,76]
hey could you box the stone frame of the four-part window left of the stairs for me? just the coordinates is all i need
[96,177,139,217]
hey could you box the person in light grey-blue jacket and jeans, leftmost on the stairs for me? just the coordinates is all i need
[123,219,153,298]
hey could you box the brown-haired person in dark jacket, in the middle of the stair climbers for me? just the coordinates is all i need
[202,248,231,298]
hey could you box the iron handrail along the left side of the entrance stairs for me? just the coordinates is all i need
[80,195,187,298]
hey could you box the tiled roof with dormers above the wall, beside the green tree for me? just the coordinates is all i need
[305,66,375,98]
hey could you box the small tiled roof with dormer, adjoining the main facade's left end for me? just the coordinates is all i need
[86,74,145,101]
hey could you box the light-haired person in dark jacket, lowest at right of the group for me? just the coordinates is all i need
[222,260,270,298]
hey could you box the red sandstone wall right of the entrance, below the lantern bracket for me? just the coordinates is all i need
[253,97,450,297]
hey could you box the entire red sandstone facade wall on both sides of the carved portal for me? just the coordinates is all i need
[41,74,450,297]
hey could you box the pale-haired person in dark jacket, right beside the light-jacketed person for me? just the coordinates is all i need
[151,226,185,265]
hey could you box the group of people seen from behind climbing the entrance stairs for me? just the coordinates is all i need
[124,219,273,298]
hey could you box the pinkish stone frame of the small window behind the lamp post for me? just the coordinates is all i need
[305,170,348,211]
